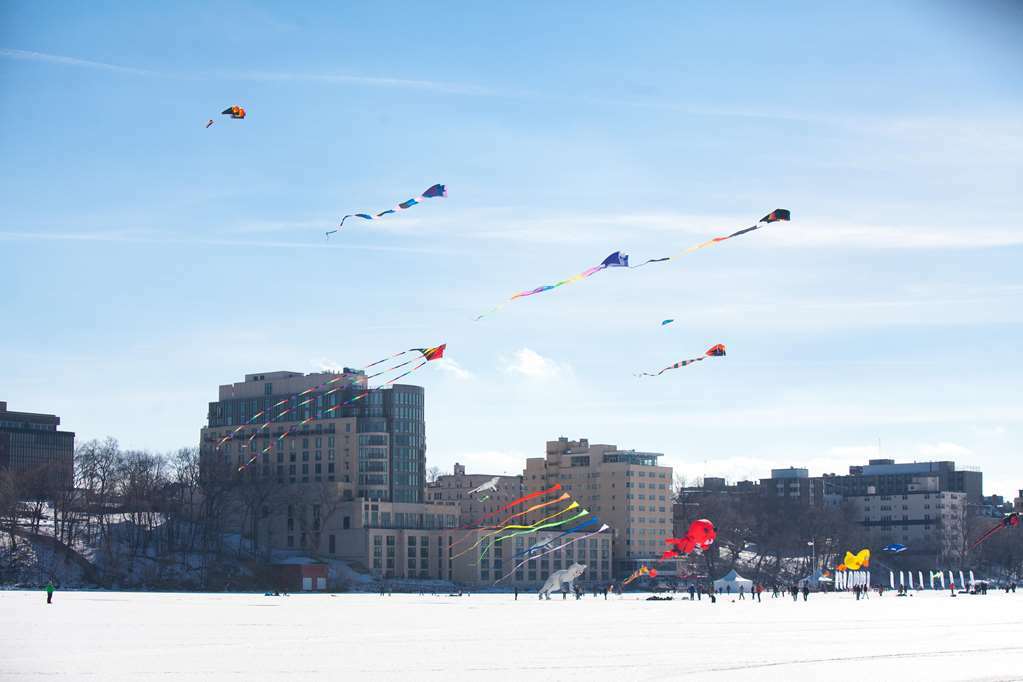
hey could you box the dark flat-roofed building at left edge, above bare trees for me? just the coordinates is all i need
[0,401,75,485]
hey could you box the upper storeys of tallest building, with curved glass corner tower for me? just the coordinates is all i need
[201,368,427,502]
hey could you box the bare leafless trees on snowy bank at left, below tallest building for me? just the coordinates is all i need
[0,438,338,589]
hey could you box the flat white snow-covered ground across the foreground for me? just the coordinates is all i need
[0,592,1023,682]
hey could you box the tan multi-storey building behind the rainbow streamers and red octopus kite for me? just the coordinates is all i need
[523,438,672,576]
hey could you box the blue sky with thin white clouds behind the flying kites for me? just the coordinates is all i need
[0,2,1023,495]
